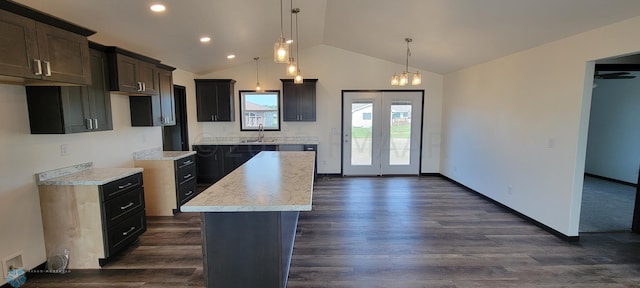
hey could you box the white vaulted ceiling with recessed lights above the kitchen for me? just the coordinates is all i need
[16,0,640,74]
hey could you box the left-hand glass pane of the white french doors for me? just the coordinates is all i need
[351,102,373,166]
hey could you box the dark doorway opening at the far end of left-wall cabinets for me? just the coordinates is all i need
[162,85,189,151]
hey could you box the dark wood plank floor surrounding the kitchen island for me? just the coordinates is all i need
[17,176,640,288]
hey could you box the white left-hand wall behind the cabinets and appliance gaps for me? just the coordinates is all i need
[0,70,193,284]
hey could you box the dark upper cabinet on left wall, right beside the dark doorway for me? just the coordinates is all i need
[129,64,176,126]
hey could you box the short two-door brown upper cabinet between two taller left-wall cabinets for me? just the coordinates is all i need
[108,47,160,95]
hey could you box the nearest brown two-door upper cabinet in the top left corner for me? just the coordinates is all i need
[0,1,95,85]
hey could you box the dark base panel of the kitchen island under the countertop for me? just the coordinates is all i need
[202,211,299,288]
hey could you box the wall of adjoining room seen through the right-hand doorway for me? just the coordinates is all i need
[585,72,640,183]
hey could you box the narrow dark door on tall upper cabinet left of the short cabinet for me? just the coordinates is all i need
[86,49,113,131]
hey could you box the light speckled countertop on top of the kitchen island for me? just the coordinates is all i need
[180,151,315,212]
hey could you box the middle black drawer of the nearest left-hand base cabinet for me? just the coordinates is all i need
[104,188,144,227]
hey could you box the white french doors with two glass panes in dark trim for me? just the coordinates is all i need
[342,91,423,175]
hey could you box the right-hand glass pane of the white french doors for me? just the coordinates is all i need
[389,100,411,165]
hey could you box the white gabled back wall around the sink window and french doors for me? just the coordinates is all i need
[194,45,443,174]
